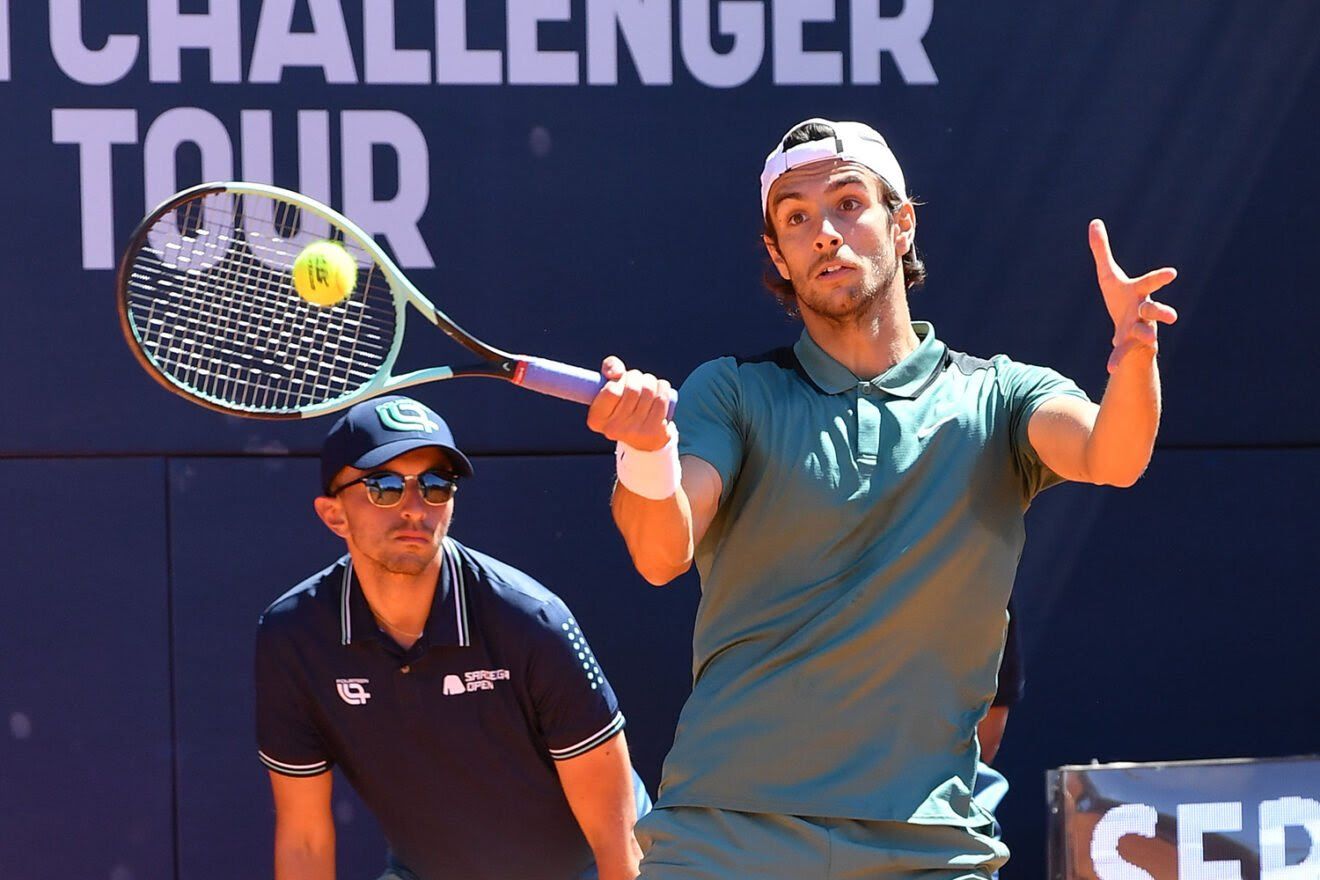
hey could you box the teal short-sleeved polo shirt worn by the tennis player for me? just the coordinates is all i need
[659,322,1085,827]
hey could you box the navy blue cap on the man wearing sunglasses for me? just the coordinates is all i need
[321,394,473,492]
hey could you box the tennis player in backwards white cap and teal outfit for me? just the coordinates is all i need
[589,119,1176,880]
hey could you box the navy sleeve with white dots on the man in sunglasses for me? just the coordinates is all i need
[528,599,624,761]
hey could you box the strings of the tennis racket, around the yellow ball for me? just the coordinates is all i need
[127,194,397,413]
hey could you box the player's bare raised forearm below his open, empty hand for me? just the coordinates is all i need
[1086,350,1160,487]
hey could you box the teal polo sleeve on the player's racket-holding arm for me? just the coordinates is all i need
[675,358,743,497]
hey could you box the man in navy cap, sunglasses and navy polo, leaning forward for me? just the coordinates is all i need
[256,397,649,880]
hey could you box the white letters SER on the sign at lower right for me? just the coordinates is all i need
[1090,796,1320,880]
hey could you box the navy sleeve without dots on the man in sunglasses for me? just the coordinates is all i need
[255,617,333,776]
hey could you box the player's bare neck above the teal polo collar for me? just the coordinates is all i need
[803,290,921,379]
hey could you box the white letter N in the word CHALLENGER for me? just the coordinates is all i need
[586,0,673,86]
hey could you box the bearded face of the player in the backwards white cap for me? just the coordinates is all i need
[766,161,913,322]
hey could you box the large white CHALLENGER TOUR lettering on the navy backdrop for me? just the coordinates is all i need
[43,0,939,269]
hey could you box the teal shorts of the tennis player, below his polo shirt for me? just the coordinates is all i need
[636,806,1008,880]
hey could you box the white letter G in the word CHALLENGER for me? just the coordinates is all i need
[678,0,766,88]
